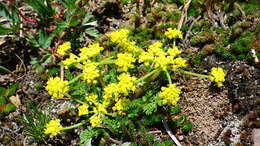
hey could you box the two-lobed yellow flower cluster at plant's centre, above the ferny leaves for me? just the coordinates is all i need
[104,73,136,100]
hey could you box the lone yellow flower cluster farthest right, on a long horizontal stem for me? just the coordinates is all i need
[210,67,226,87]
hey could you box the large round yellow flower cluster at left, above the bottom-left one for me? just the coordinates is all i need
[45,77,69,98]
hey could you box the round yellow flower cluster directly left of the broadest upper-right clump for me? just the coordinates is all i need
[116,53,135,71]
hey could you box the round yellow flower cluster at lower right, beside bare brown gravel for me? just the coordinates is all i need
[159,84,181,105]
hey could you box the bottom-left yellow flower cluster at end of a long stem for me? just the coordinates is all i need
[44,119,62,138]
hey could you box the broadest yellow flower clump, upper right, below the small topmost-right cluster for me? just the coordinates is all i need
[139,42,187,70]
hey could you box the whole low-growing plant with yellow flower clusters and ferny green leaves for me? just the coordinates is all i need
[36,28,225,145]
